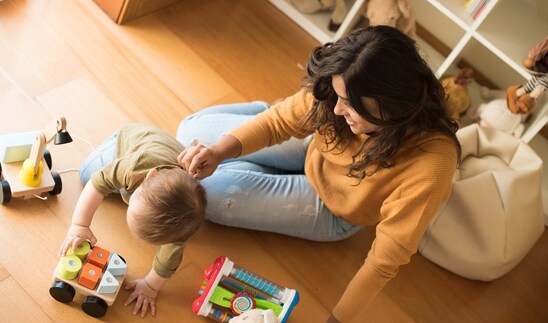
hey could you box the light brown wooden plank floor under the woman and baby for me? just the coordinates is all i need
[0,0,548,323]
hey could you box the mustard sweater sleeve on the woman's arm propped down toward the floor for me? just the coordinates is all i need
[333,143,456,322]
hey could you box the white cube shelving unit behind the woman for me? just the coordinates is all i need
[269,0,548,142]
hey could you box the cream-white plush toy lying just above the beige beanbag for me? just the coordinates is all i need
[477,99,525,138]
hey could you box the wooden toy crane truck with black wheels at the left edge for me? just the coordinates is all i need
[0,116,72,204]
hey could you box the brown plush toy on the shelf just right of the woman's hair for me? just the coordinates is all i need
[441,68,474,121]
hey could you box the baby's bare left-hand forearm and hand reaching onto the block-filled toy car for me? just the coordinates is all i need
[59,182,104,256]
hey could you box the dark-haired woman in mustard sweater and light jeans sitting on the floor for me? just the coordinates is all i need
[177,26,461,322]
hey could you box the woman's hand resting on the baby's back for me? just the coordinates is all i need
[177,144,222,179]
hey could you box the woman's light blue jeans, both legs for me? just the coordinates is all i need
[177,102,361,241]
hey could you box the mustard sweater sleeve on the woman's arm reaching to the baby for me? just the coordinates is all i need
[230,89,314,155]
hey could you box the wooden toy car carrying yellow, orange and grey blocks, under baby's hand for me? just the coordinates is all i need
[49,241,127,317]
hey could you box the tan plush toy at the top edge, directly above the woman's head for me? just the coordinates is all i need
[362,0,416,38]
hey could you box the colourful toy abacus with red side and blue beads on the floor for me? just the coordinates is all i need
[192,256,299,323]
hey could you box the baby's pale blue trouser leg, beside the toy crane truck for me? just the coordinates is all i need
[80,132,118,185]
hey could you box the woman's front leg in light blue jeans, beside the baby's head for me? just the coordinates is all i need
[201,161,361,241]
